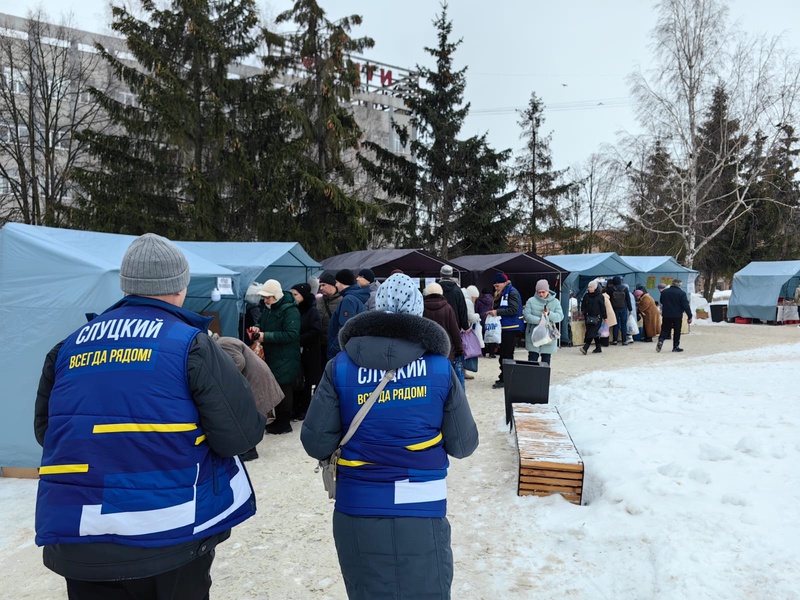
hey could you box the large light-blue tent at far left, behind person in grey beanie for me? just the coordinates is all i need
[0,223,239,467]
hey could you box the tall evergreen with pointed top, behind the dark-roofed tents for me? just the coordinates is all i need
[361,3,512,258]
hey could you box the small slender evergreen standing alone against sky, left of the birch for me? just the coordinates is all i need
[514,93,570,252]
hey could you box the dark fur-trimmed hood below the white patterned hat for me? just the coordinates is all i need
[339,311,450,370]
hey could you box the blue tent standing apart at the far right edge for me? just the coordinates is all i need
[728,260,800,321]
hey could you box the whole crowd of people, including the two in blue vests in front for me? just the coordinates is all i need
[29,234,691,600]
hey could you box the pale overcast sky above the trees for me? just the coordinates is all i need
[0,0,800,168]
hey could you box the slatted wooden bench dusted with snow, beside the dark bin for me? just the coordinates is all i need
[513,404,583,505]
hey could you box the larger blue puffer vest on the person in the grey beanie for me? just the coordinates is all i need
[36,297,255,547]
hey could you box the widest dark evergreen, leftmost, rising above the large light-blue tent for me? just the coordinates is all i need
[75,0,291,240]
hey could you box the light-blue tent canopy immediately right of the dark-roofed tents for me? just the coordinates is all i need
[545,252,636,342]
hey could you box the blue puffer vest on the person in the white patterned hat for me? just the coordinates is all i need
[334,352,451,517]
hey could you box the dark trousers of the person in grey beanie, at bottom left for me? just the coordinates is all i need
[67,550,214,600]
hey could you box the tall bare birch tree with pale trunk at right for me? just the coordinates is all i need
[630,0,800,267]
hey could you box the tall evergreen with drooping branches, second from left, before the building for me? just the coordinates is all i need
[267,0,375,256]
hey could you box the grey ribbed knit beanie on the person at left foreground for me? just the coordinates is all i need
[119,233,189,296]
